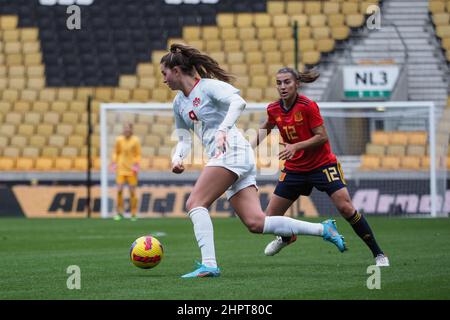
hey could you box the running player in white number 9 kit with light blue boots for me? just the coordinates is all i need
[160,44,346,278]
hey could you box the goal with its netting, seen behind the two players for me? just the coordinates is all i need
[100,102,450,218]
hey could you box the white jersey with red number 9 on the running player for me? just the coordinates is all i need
[173,79,251,158]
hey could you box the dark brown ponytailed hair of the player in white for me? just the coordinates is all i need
[160,43,234,83]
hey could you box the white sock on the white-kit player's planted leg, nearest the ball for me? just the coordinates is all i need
[188,207,217,268]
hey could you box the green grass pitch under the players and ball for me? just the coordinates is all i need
[0,217,450,300]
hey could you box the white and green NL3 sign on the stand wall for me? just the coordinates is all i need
[343,65,400,98]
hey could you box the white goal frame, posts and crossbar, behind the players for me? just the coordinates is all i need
[100,101,438,218]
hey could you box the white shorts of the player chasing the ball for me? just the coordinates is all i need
[206,148,258,200]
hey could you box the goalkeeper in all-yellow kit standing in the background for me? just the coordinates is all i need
[111,123,141,221]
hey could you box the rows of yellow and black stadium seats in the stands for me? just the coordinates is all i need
[0,0,450,171]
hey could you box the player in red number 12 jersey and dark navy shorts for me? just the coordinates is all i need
[252,68,389,266]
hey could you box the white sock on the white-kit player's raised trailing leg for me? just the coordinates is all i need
[263,216,323,237]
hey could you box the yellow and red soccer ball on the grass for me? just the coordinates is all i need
[130,235,164,269]
